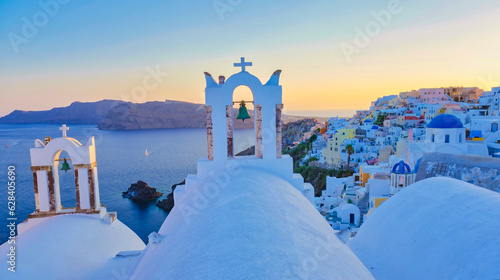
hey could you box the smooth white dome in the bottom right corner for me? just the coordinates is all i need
[348,177,500,280]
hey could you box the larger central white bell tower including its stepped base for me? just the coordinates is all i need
[174,58,314,201]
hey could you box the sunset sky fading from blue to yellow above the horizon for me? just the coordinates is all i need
[0,0,500,116]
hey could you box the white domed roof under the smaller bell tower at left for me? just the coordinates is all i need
[0,214,145,280]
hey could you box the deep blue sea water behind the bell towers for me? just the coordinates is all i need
[0,124,255,244]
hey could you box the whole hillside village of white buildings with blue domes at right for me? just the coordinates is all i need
[316,87,500,230]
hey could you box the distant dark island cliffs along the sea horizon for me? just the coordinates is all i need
[0,100,326,130]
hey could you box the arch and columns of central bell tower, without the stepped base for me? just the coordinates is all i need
[205,58,283,161]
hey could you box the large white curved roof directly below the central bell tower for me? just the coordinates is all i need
[132,167,373,280]
